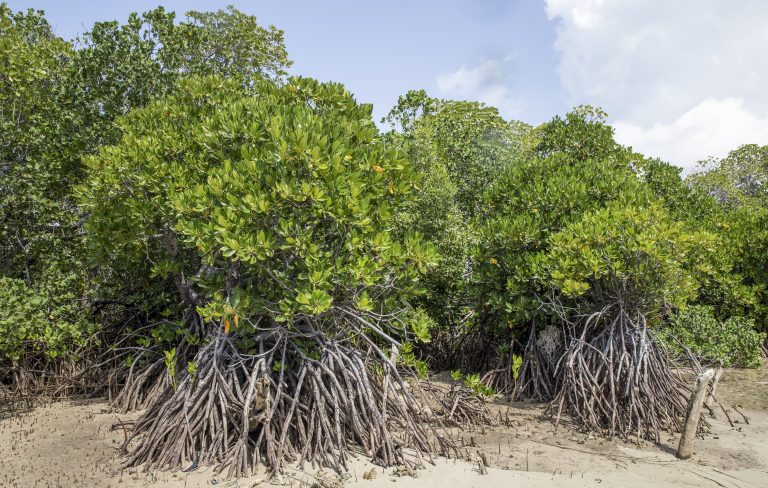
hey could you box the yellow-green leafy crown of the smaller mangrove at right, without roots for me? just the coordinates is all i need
[542,203,713,320]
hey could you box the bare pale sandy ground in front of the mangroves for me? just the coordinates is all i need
[0,366,768,488]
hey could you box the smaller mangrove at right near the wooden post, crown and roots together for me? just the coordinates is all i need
[529,202,711,442]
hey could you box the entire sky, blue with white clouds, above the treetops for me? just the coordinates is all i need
[8,0,768,170]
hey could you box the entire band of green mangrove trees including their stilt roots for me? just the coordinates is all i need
[0,0,768,475]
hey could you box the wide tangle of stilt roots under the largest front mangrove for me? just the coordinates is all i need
[127,312,460,476]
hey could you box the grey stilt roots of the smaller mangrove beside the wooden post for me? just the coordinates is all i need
[548,305,705,442]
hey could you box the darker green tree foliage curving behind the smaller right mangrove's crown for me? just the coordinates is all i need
[475,153,648,332]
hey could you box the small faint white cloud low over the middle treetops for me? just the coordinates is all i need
[437,60,521,118]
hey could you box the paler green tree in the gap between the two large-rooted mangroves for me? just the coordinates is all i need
[384,91,531,358]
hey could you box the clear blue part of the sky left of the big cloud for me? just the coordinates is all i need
[9,0,566,122]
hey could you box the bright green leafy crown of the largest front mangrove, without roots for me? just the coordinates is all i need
[81,77,435,328]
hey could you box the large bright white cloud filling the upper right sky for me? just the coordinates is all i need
[546,0,768,168]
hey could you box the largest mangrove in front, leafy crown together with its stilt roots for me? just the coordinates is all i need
[80,77,444,474]
